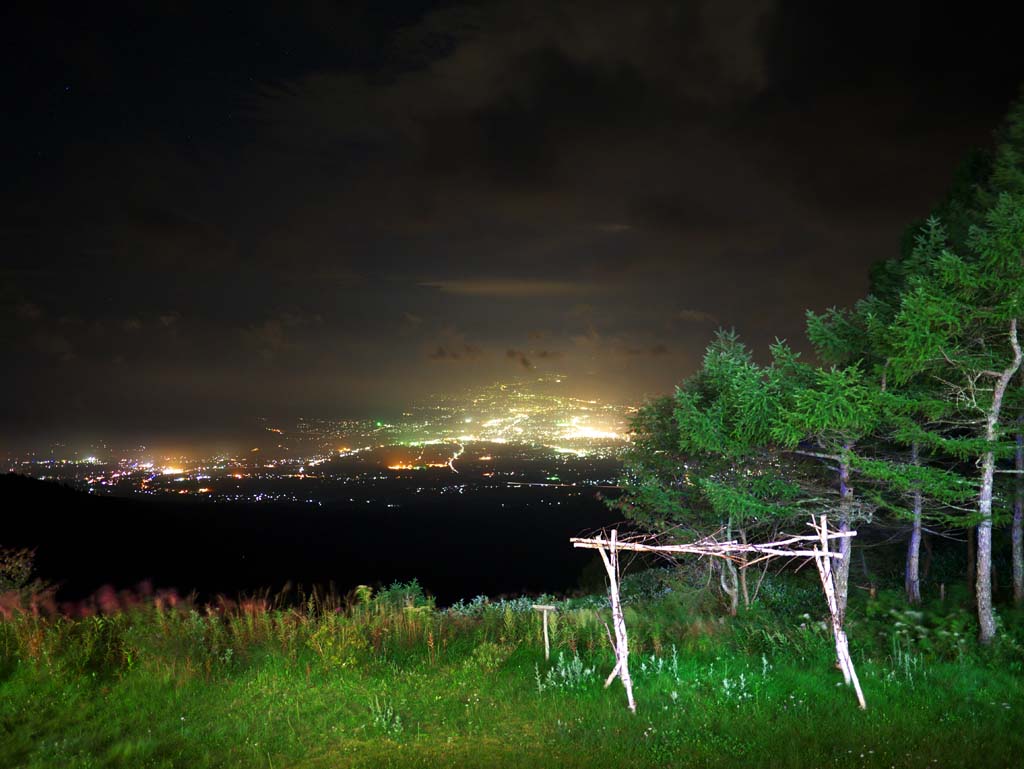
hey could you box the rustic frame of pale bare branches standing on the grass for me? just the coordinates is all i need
[569,515,867,713]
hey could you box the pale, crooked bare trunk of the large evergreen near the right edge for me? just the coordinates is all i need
[975,318,1024,644]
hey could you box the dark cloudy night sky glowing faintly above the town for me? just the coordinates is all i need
[6,0,1024,447]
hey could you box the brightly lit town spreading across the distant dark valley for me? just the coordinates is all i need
[7,375,635,507]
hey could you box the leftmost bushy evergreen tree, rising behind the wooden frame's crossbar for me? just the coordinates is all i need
[614,331,810,612]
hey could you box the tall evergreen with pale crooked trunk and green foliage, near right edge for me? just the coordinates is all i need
[891,194,1024,643]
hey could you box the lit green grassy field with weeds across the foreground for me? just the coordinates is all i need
[0,574,1024,769]
